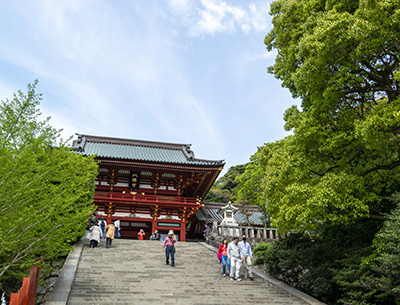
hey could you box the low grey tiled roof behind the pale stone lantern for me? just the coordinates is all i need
[196,202,265,226]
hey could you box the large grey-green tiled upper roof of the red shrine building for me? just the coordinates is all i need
[72,134,225,166]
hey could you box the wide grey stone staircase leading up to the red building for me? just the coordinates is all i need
[68,239,307,305]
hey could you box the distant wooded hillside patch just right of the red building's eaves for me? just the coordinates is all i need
[204,164,245,203]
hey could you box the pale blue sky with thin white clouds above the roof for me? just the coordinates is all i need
[0,0,298,171]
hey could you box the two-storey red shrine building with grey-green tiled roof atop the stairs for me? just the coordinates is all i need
[72,134,225,241]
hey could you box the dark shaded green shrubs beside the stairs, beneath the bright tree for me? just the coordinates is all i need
[254,220,380,305]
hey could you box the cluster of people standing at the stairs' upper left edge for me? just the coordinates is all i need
[87,213,121,249]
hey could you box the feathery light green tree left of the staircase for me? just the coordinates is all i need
[0,81,97,294]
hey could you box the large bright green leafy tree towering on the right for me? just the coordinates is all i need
[256,0,400,230]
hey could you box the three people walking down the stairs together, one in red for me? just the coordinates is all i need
[217,234,254,281]
